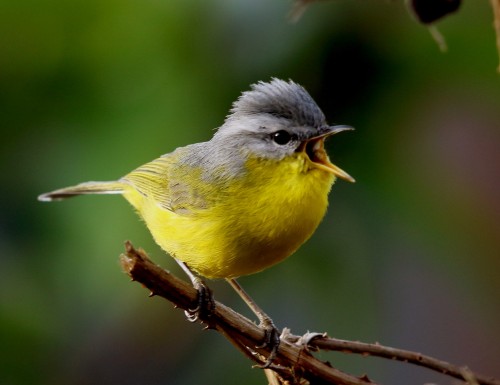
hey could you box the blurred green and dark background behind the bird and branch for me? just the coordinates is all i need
[0,0,500,385]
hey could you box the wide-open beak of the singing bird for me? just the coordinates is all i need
[301,125,355,183]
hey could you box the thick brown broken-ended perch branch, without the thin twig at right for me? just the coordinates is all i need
[120,242,374,385]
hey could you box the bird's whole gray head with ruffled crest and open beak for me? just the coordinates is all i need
[214,78,354,182]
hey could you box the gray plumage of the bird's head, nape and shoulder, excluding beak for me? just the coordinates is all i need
[180,78,329,180]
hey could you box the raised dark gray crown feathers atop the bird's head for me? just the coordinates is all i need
[226,78,326,127]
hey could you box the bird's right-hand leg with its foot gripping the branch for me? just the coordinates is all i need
[226,278,280,369]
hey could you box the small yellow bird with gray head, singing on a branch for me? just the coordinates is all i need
[39,78,354,364]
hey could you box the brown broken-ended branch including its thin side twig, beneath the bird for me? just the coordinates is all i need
[120,242,500,385]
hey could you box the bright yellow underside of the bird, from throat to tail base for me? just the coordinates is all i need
[126,154,335,278]
